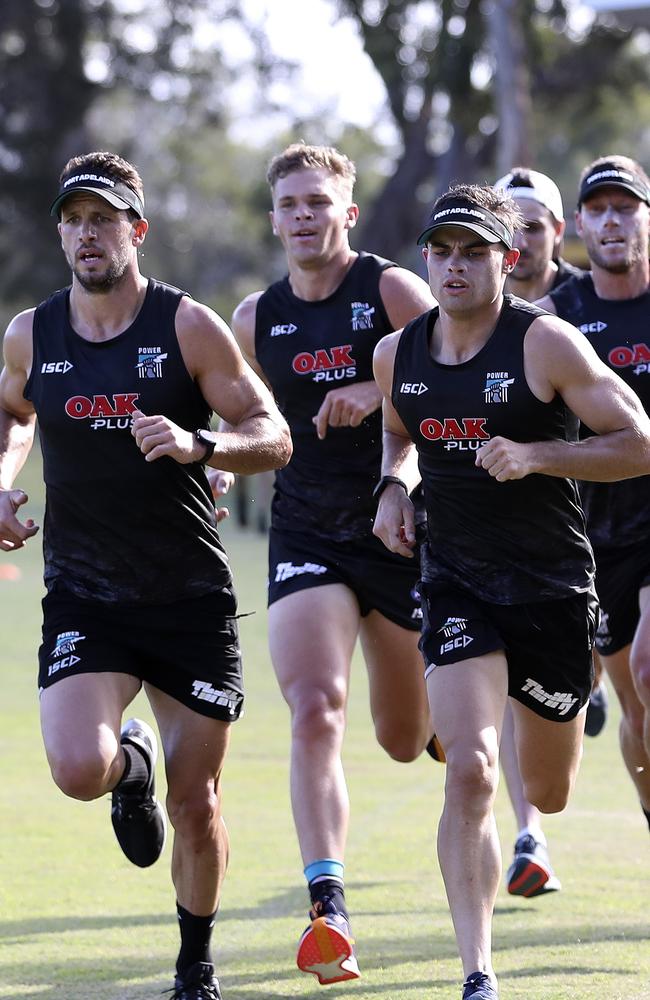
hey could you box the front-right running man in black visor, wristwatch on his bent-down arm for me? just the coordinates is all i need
[375,185,650,1000]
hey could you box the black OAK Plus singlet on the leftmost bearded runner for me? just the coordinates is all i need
[24,280,230,604]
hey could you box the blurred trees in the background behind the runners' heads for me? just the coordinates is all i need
[0,0,650,314]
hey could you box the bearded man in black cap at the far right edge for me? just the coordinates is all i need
[543,156,650,826]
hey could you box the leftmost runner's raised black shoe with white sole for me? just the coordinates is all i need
[111,719,167,868]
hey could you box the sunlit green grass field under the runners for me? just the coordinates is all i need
[0,462,650,1000]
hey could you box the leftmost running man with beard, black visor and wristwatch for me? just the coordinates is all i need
[0,153,291,1000]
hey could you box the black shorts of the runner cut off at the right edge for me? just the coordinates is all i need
[594,545,650,656]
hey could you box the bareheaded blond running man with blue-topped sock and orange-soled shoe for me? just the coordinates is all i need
[221,144,432,983]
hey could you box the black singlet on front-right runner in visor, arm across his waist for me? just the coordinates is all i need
[392,295,593,604]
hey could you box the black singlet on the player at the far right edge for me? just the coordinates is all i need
[551,272,650,549]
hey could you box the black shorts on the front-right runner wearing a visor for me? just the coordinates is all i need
[420,583,598,722]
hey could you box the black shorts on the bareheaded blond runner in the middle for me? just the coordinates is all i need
[268,528,422,631]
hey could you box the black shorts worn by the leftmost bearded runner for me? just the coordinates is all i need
[38,587,244,722]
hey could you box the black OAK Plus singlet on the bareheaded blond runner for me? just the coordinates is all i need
[255,253,396,541]
